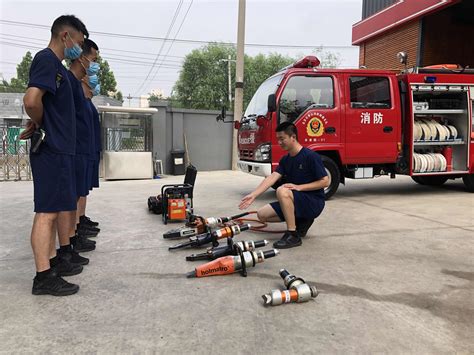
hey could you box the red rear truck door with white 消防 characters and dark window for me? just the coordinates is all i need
[344,74,401,164]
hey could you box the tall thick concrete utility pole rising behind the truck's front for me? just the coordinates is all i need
[232,0,245,170]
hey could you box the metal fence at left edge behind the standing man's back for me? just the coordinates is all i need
[0,125,31,181]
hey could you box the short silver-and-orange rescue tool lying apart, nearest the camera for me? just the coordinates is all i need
[262,269,318,306]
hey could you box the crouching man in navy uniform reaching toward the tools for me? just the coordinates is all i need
[239,122,329,249]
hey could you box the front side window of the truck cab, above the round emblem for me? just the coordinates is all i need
[279,76,334,122]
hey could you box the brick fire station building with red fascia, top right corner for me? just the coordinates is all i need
[352,0,474,69]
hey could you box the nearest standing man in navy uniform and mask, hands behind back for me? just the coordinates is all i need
[20,15,89,296]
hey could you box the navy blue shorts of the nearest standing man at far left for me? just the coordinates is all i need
[30,148,77,213]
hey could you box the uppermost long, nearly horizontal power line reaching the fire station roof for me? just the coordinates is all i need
[0,20,358,49]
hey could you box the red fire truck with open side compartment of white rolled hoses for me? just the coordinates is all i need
[234,56,474,198]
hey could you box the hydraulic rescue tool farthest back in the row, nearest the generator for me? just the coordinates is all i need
[163,212,249,239]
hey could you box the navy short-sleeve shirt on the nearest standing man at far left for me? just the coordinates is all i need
[28,48,76,155]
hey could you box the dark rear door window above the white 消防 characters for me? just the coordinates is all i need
[349,76,392,109]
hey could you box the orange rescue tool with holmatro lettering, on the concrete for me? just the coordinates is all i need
[187,248,279,277]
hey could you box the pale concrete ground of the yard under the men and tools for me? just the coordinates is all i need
[0,171,474,354]
